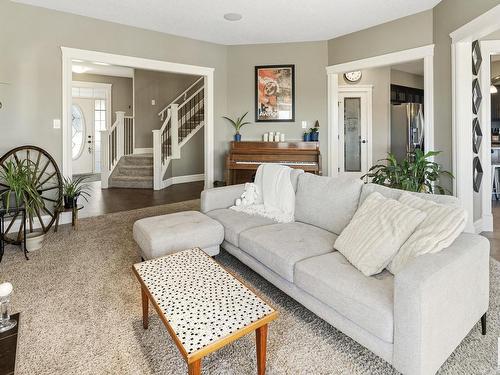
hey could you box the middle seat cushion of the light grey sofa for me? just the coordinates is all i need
[240,222,337,282]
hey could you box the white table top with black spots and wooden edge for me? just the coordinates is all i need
[134,248,275,356]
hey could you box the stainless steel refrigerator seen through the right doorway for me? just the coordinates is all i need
[391,103,424,160]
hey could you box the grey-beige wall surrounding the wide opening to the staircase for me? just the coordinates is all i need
[0,1,229,178]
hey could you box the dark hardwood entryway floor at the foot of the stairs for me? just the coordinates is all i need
[79,181,204,217]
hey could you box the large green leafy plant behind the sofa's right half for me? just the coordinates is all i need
[361,149,454,194]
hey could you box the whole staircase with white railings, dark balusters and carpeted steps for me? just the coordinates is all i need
[101,77,205,190]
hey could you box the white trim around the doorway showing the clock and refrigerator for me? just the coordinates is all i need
[326,44,434,176]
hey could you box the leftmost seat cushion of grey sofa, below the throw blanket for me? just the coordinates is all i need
[206,208,276,247]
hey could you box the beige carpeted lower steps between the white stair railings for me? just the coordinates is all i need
[109,154,153,189]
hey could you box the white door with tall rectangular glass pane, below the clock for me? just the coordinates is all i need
[338,90,371,178]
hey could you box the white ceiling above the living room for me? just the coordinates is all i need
[15,0,440,45]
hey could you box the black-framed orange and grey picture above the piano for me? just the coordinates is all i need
[255,65,295,122]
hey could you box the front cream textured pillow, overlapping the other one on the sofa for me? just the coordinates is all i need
[334,193,426,276]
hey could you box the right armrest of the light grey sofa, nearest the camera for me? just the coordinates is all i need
[393,233,490,375]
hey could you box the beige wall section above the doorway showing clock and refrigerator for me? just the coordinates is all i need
[328,10,432,65]
